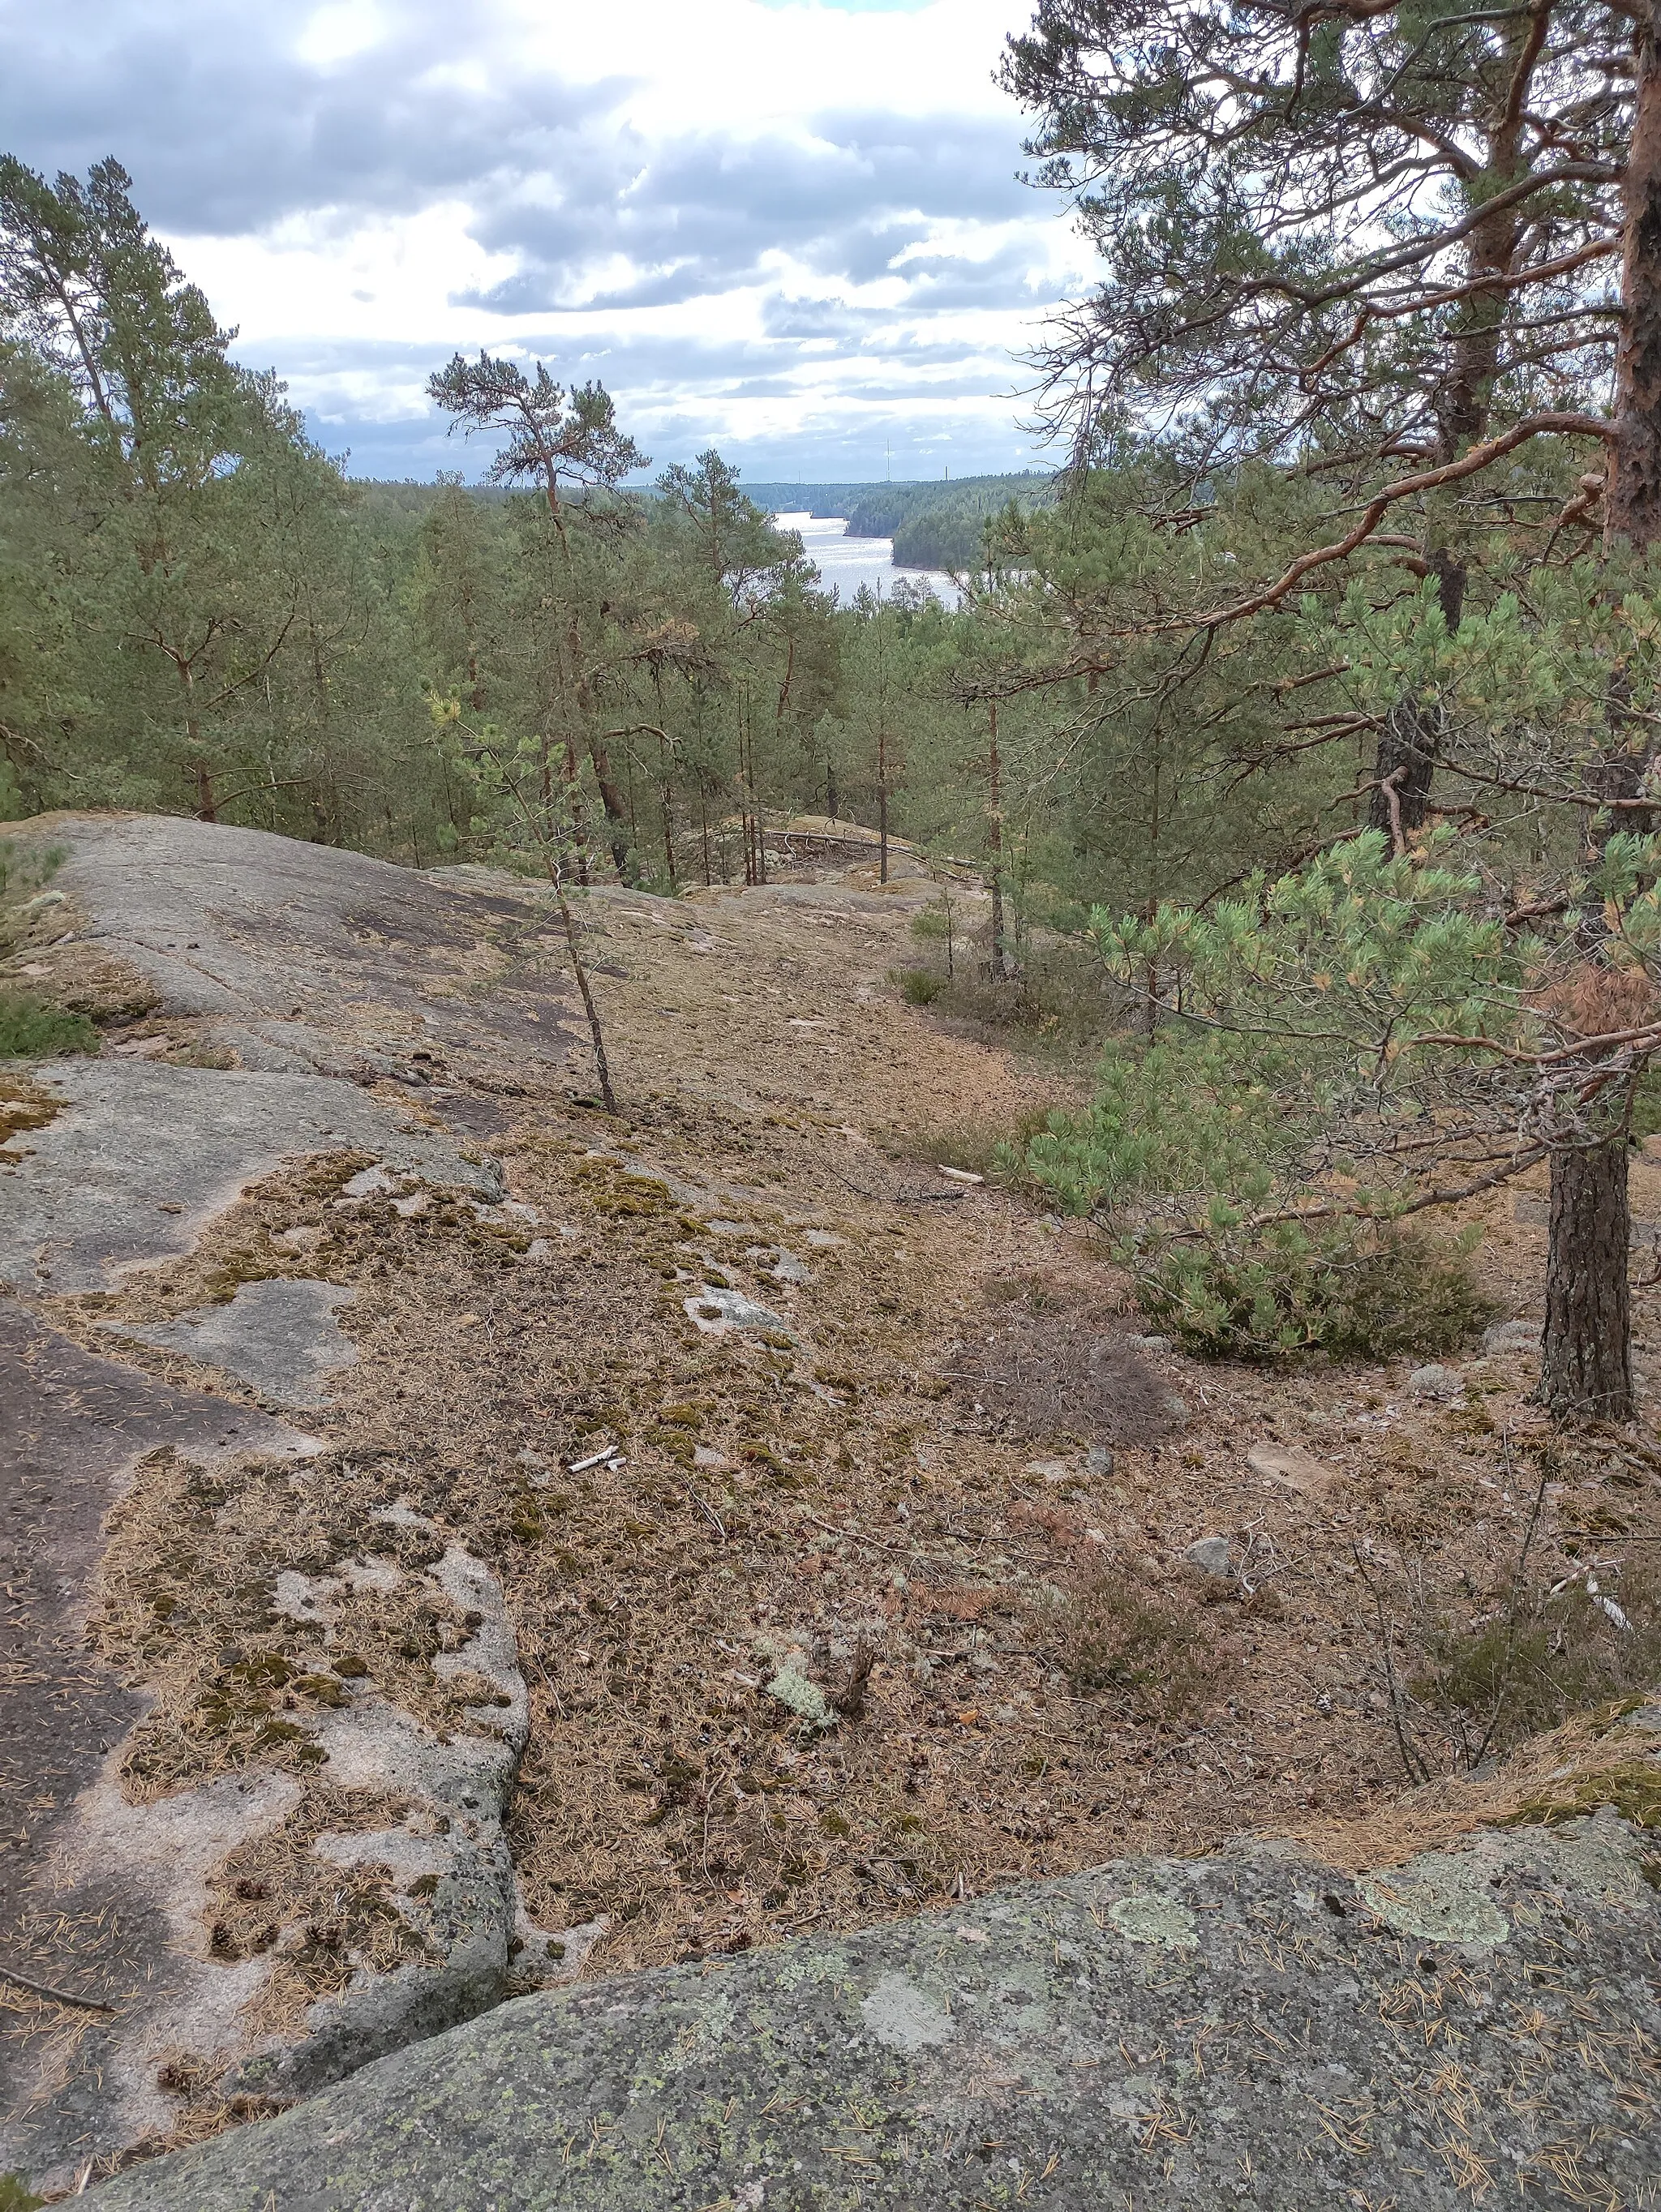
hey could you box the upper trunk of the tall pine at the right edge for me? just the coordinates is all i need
[1603,0,1661,547]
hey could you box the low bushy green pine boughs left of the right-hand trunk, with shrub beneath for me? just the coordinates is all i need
[1024,832,1661,1358]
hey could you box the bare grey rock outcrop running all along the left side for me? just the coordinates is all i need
[0,817,573,2192]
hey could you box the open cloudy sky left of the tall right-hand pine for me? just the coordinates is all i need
[0,0,1088,482]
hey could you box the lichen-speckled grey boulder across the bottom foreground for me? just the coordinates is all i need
[88,1816,1661,2212]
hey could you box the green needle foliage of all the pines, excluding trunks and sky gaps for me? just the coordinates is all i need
[0,160,1661,1398]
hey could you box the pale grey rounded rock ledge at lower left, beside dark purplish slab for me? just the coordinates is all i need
[0,1544,526,2188]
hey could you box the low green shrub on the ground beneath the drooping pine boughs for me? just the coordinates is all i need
[1137,1224,1495,1361]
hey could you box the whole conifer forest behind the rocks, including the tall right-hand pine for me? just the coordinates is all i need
[0,0,1661,1420]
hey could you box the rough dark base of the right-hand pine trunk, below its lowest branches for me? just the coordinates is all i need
[1537,1130,1634,1420]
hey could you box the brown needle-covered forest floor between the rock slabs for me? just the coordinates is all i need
[48,849,1661,1971]
